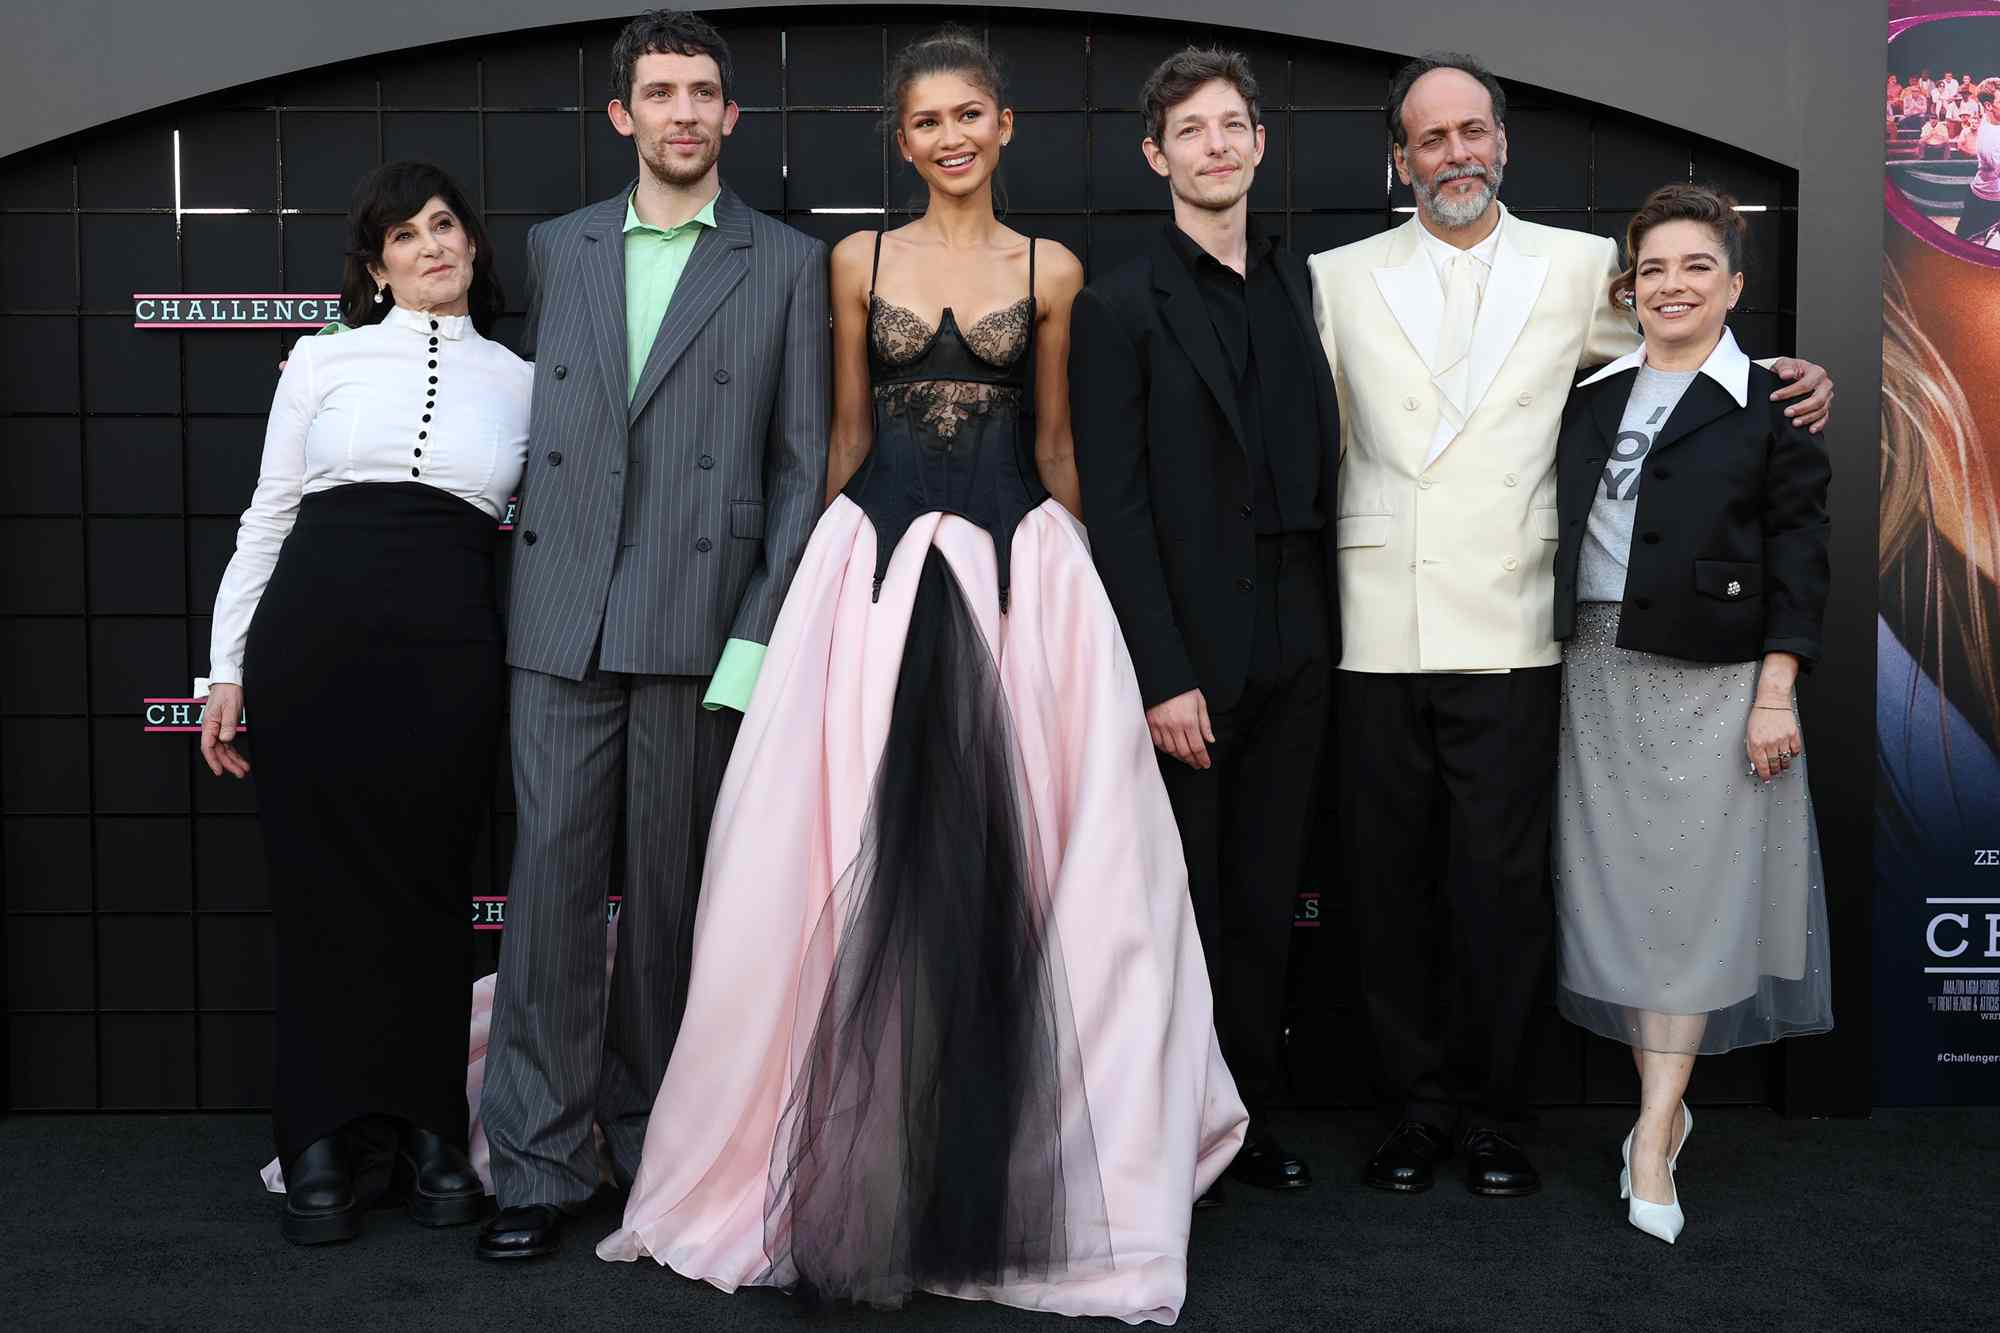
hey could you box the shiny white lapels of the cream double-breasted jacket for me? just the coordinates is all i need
[1374,204,1548,462]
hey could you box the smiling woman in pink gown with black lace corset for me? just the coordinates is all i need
[598,30,1246,1323]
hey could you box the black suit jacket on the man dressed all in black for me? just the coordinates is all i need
[1070,228,1340,709]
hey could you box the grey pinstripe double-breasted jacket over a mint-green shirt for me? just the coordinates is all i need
[506,186,832,681]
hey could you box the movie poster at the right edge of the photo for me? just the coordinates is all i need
[1874,0,2000,1105]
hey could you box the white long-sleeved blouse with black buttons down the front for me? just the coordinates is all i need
[196,306,534,695]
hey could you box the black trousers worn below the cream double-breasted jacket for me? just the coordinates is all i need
[1334,667,1562,1129]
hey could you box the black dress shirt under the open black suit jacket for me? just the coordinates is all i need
[1170,220,1326,536]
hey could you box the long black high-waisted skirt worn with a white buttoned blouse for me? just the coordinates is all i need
[244,482,506,1167]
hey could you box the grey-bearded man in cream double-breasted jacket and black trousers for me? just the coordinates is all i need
[1310,54,1830,1197]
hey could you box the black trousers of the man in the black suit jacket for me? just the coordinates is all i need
[1160,532,1332,1125]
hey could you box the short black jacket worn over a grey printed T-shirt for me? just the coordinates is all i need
[1556,364,1832,667]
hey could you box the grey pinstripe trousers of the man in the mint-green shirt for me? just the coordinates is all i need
[480,669,740,1209]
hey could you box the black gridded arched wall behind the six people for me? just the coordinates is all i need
[0,10,1808,1109]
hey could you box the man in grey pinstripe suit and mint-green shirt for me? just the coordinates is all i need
[478,12,830,1259]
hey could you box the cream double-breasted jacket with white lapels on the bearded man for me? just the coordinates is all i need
[1310,208,1640,673]
